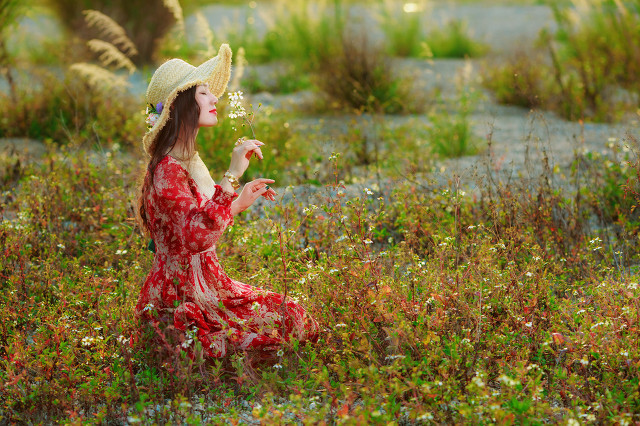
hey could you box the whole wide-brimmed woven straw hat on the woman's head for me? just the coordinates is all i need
[142,44,231,155]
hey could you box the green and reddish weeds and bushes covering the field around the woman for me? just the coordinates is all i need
[0,0,640,425]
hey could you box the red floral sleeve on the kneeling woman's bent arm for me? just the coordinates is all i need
[154,161,238,253]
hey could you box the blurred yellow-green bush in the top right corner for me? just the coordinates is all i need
[485,0,640,121]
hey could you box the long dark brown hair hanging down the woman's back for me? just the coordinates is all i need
[138,86,200,233]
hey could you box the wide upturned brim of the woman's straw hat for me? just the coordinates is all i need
[142,44,232,155]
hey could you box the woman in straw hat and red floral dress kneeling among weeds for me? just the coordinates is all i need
[136,44,318,357]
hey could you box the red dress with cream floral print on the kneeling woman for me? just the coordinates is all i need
[136,156,318,357]
